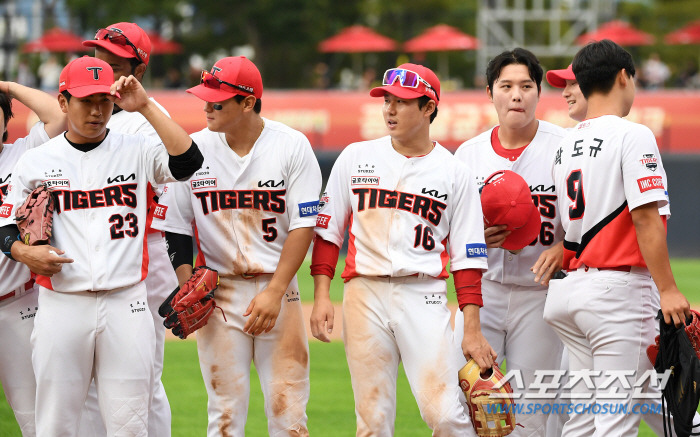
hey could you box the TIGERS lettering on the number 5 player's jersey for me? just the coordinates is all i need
[192,190,287,215]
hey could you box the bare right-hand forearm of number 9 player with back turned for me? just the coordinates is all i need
[630,202,676,293]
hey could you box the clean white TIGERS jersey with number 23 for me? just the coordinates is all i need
[0,131,175,292]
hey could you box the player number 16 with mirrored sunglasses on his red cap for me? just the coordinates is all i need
[311,64,496,436]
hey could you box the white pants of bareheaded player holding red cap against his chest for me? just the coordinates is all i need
[455,279,564,437]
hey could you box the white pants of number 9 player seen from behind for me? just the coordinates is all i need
[544,268,656,437]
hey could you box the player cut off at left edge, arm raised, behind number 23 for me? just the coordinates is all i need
[0,82,66,437]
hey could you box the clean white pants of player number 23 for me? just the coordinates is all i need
[31,282,155,437]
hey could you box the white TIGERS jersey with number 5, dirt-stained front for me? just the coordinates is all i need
[153,119,321,275]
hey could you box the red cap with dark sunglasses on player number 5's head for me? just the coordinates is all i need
[187,56,262,102]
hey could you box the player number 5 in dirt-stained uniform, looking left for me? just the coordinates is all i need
[153,56,321,437]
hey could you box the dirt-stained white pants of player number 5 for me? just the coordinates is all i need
[197,274,310,437]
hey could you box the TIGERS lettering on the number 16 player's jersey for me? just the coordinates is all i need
[352,188,447,226]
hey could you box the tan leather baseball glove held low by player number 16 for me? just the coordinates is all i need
[459,360,516,437]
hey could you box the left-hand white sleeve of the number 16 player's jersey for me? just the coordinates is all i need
[316,149,352,247]
